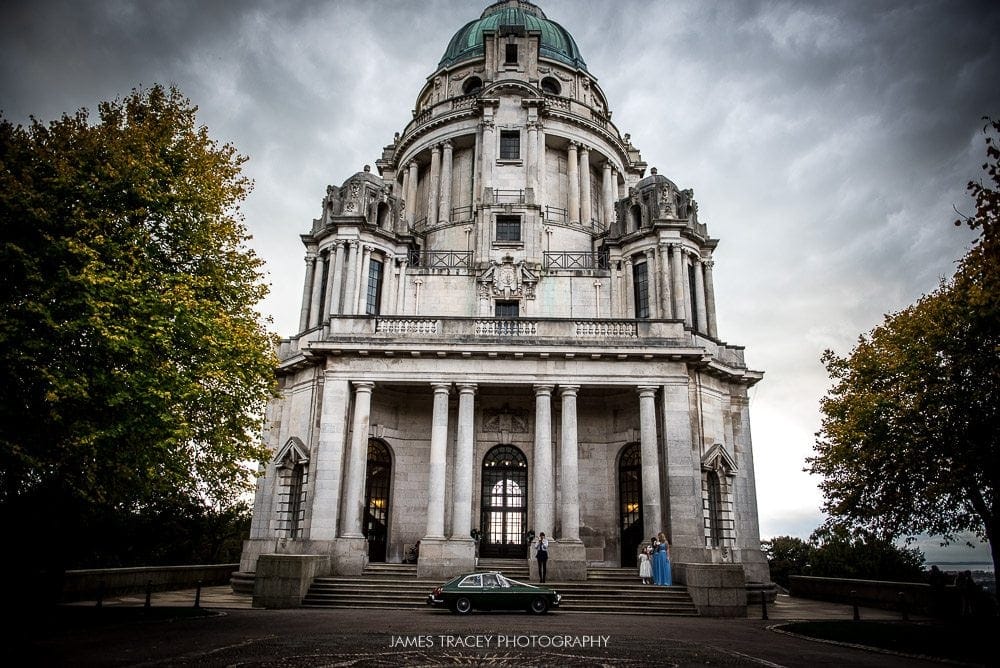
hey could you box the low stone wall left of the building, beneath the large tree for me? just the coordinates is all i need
[62,564,239,602]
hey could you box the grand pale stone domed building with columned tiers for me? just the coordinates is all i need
[241,0,769,612]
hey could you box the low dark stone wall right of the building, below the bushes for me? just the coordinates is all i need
[789,575,958,615]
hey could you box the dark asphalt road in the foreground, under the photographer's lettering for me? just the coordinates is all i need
[17,608,941,668]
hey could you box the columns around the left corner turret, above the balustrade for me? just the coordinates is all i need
[299,239,409,332]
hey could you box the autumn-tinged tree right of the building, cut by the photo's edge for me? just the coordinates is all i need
[807,121,1000,570]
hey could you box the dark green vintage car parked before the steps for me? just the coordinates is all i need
[427,571,562,615]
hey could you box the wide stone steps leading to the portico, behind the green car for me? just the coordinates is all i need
[302,560,698,616]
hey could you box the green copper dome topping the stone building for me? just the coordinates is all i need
[438,0,587,70]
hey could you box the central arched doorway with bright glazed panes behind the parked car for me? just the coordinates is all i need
[479,445,528,559]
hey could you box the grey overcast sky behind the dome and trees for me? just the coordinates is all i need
[0,0,1000,560]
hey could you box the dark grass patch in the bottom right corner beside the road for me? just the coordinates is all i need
[781,618,1000,664]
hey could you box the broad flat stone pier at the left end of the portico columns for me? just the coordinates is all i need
[309,372,351,540]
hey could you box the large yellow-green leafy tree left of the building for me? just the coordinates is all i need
[0,86,274,580]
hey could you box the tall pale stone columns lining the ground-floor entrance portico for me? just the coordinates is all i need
[312,381,662,543]
